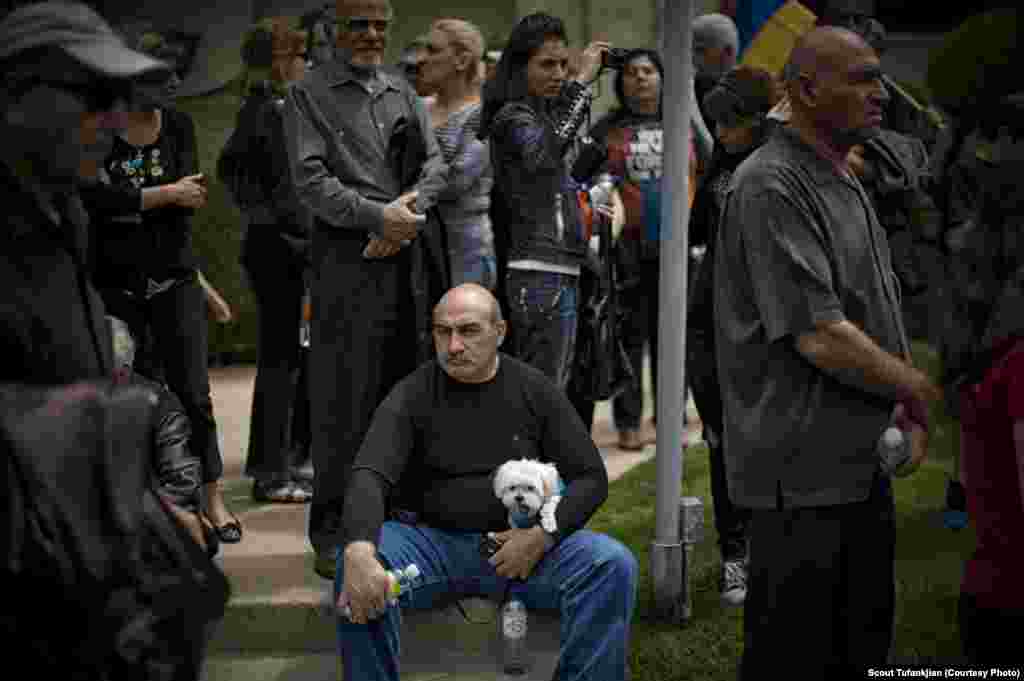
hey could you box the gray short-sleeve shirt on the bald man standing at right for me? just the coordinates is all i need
[715,128,909,508]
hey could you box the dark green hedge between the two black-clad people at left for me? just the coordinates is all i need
[177,86,258,363]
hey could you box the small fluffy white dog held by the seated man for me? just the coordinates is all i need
[495,459,565,533]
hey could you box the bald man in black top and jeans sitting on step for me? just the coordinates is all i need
[336,284,637,681]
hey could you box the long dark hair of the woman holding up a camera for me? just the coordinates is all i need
[479,12,568,139]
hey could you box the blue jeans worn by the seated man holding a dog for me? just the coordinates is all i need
[335,520,639,681]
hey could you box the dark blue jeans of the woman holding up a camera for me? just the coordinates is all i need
[506,269,580,390]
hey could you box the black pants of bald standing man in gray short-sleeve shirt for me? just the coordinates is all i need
[739,475,895,681]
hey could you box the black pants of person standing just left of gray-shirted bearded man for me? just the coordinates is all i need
[246,259,304,480]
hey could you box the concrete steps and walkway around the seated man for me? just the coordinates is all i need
[205,367,699,681]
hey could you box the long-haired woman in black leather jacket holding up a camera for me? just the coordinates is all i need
[480,12,609,389]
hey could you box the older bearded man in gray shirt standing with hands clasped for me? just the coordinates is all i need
[285,0,447,576]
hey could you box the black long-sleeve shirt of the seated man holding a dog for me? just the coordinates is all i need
[343,355,608,545]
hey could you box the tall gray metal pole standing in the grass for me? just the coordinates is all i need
[650,0,699,622]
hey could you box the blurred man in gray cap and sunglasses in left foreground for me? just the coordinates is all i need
[0,2,166,385]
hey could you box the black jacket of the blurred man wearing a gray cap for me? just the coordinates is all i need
[0,163,113,385]
